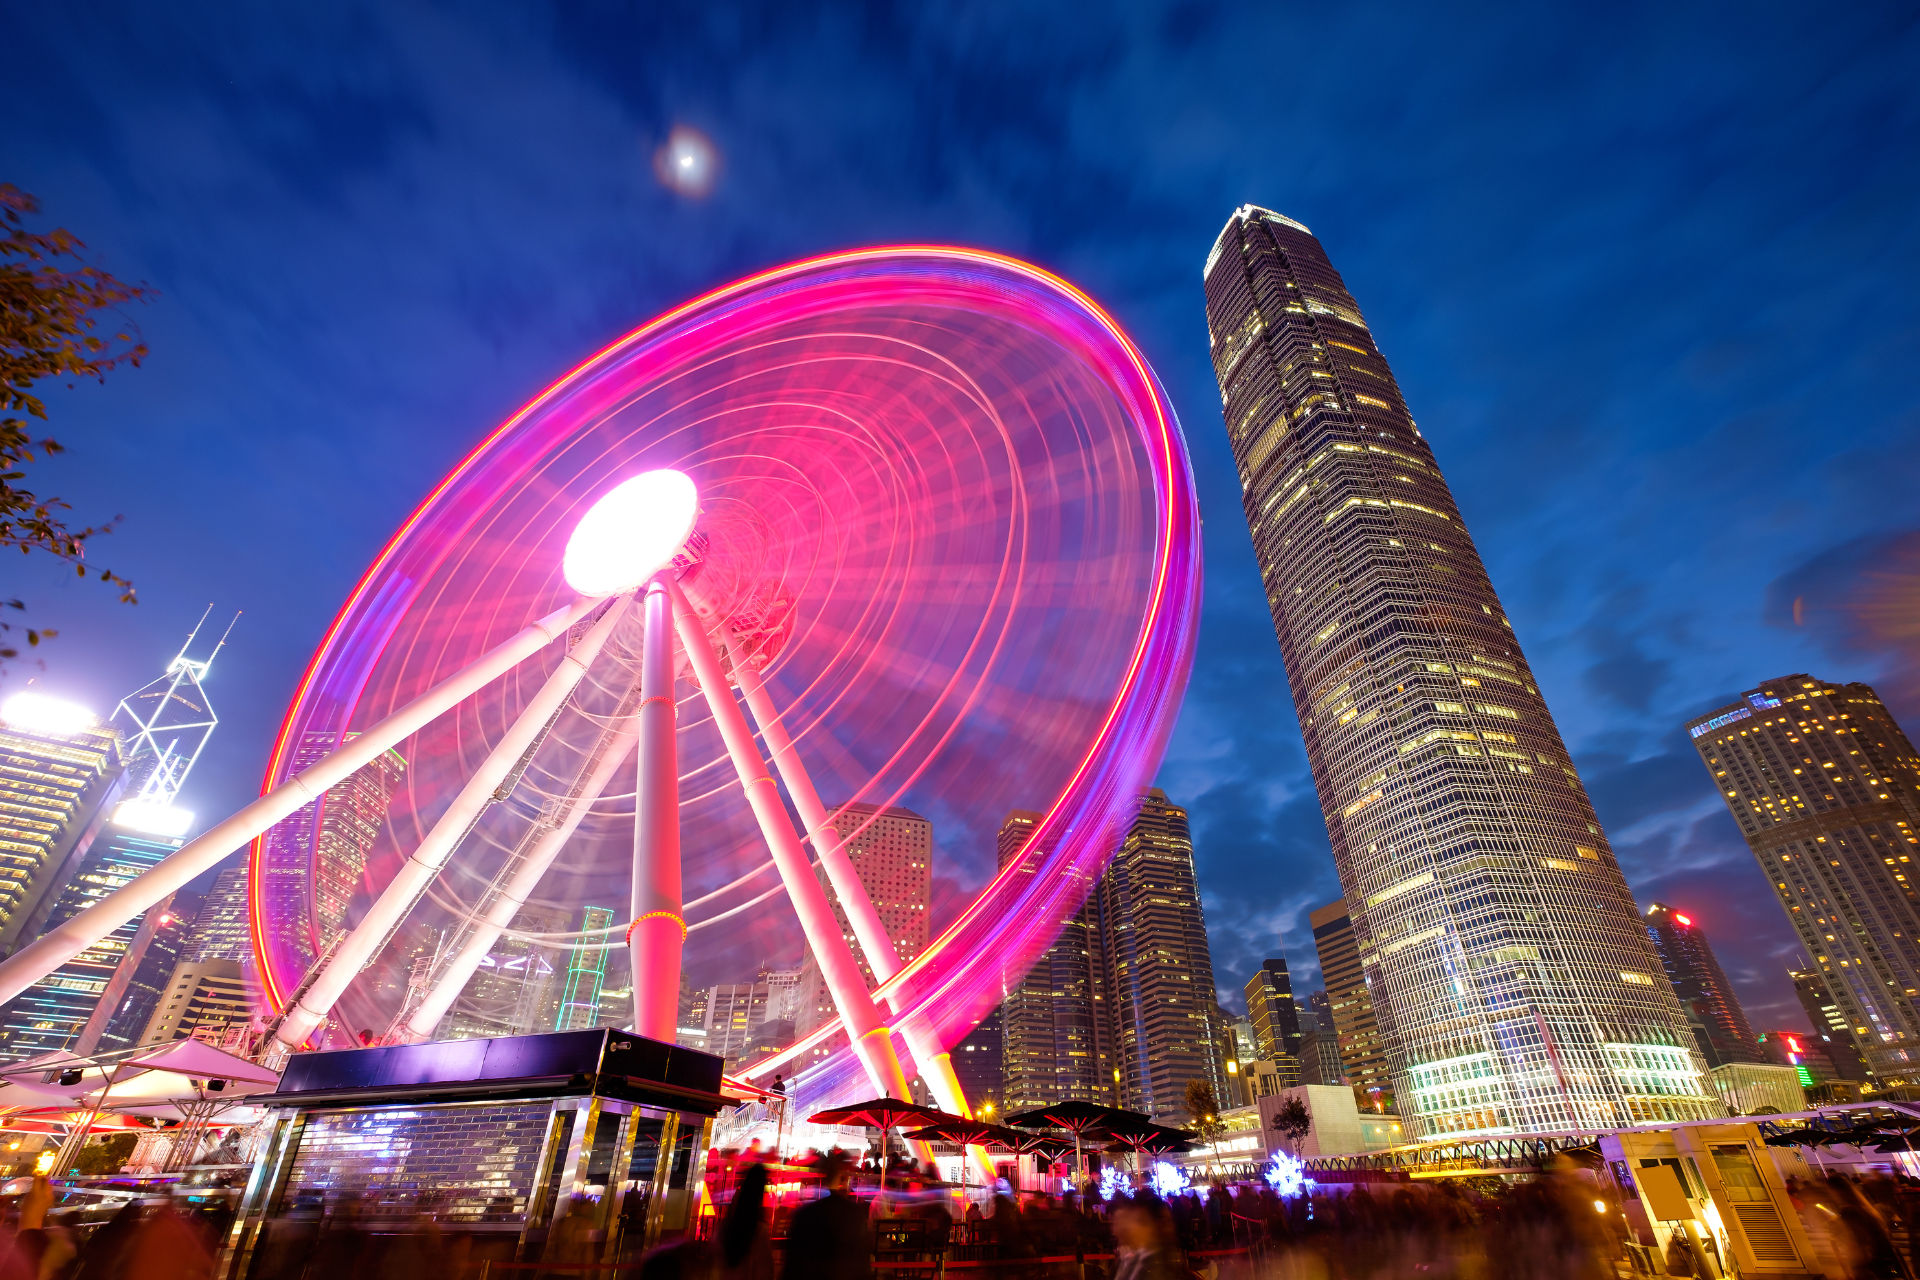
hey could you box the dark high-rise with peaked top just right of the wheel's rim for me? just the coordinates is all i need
[1094,787,1229,1119]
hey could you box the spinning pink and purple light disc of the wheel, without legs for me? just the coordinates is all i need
[250,246,1200,1088]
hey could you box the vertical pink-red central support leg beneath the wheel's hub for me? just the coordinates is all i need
[626,574,683,1044]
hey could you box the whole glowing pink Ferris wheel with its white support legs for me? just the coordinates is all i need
[0,246,1200,1113]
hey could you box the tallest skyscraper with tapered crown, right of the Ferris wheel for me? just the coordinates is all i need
[1204,205,1718,1136]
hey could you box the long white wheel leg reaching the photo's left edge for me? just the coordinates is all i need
[0,599,601,1002]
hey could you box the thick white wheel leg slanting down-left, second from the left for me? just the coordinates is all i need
[273,597,626,1050]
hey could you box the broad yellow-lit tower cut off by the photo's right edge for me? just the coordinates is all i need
[1686,674,1920,1084]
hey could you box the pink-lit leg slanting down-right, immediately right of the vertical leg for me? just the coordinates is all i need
[670,585,910,1100]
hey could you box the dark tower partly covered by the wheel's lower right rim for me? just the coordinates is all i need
[998,810,1114,1111]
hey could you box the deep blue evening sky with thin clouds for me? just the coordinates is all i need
[15,0,1920,1025]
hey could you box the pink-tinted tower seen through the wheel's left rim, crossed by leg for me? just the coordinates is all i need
[265,733,407,961]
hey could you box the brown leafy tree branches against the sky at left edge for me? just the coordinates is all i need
[0,182,154,658]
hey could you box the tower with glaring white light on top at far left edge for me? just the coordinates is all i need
[0,693,127,954]
